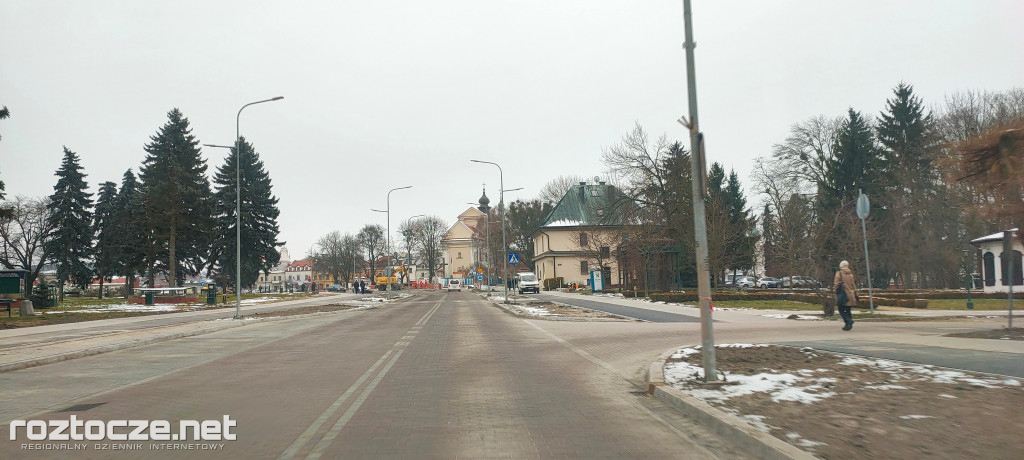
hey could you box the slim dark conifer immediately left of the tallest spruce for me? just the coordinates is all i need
[112,169,152,298]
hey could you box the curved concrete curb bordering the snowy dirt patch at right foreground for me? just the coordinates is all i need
[647,349,816,459]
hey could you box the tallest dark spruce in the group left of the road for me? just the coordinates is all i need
[139,109,214,286]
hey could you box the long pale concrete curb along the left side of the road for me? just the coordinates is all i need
[0,305,377,374]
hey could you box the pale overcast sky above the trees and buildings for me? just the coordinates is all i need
[0,0,1024,258]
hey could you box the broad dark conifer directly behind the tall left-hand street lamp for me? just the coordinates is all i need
[213,134,284,287]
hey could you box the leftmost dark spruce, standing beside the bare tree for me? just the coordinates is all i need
[46,147,92,296]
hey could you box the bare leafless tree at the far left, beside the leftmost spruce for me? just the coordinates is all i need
[0,197,50,297]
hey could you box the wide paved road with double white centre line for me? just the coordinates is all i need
[0,292,742,459]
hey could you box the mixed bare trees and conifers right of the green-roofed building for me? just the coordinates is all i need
[603,83,1024,288]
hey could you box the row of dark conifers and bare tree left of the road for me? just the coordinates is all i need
[0,109,284,295]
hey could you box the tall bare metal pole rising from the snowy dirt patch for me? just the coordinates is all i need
[681,0,718,382]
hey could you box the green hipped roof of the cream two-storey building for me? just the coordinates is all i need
[541,183,625,227]
